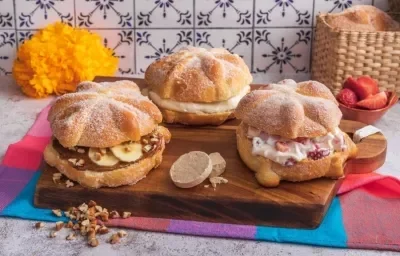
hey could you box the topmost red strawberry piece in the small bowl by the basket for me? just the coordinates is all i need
[343,76,379,100]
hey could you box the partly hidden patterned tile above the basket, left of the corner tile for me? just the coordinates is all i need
[314,0,376,25]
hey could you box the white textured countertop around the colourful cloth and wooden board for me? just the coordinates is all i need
[0,76,400,256]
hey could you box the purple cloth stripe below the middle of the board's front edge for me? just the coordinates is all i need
[168,220,257,239]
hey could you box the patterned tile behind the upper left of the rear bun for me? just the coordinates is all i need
[136,29,194,73]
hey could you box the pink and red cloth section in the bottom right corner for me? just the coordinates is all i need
[339,176,400,251]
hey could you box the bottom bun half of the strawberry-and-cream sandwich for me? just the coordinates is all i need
[236,123,357,187]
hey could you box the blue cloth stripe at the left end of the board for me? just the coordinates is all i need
[0,171,67,221]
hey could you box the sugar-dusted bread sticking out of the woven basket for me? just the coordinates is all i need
[325,5,400,32]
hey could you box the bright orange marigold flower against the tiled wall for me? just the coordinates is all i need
[13,22,118,98]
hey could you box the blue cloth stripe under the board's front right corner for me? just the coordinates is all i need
[256,197,347,248]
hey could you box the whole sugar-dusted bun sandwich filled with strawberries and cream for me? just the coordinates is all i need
[235,79,357,187]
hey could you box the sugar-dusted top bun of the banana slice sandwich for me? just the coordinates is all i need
[48,81,162,148]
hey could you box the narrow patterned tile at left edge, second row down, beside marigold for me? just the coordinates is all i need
[0,30,17,75]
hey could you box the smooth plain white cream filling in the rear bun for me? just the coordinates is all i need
[148,85,250,113]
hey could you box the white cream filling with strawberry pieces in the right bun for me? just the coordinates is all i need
[247,127,347,166]
